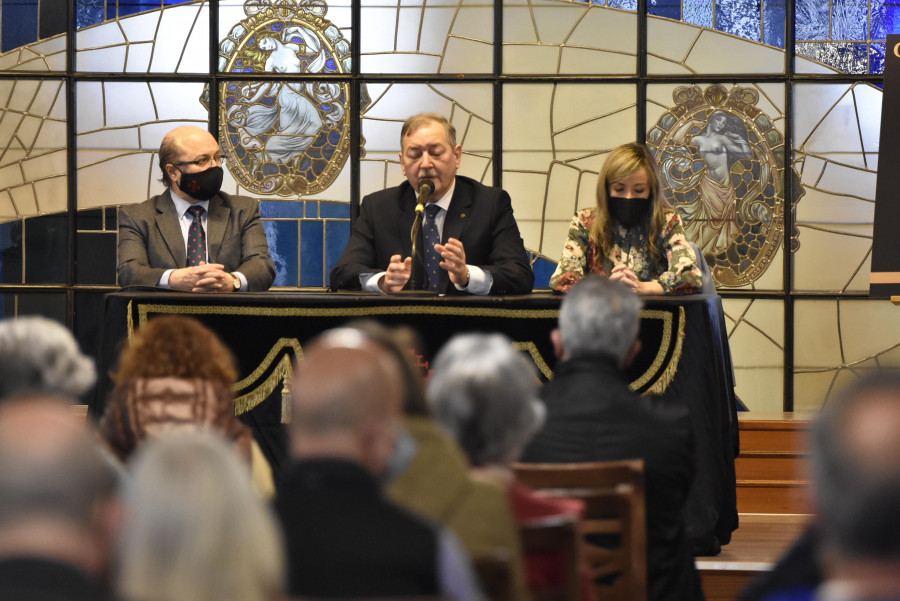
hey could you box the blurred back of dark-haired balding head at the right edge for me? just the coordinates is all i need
[811,372,900,562]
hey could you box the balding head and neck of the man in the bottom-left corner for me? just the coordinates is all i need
[0,395,117,572]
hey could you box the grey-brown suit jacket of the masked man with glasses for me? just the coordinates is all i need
[116,189,275,291]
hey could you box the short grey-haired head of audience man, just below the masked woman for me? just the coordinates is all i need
[559,275,642,365]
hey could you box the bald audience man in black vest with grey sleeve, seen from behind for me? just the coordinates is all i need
[276,328,481,599]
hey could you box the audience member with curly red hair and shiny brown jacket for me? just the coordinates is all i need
[100,315,274,496]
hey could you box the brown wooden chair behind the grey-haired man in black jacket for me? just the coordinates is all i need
[513,459,647,601]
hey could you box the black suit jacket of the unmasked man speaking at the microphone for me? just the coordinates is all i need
[331,175,534,294]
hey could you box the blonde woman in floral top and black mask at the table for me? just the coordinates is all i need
[550,143,703,294]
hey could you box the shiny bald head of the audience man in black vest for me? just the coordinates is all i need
[291,329,403,473]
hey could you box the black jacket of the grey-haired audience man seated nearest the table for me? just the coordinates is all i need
[522,356,703,601]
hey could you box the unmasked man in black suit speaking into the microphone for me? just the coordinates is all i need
[331,113,534,295]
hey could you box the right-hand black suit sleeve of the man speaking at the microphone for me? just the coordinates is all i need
[473,190,534,294]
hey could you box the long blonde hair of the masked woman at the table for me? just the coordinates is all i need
[590,142,674,261]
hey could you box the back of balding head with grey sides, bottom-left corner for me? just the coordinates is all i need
[0,395,118,554]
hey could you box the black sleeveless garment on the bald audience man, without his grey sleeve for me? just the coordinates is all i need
[275,458,439,598]
